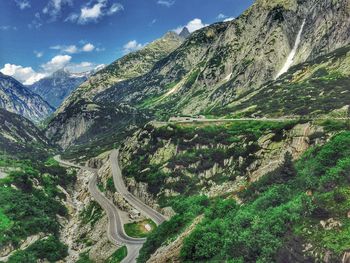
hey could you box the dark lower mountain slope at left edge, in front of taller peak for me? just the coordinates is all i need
[0,109,52,157]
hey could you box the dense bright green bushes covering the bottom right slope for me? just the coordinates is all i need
[138,132,350,262]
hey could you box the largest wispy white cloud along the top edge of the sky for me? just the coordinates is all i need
[65,0,124,25]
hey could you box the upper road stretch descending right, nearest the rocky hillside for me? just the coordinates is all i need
[110,150,166,225]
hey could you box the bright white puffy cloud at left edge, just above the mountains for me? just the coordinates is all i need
[0,64,46,85]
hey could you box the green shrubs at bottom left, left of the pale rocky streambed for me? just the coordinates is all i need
[0,156,75,262]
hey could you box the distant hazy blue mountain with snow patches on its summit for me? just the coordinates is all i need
[28,69,90,108]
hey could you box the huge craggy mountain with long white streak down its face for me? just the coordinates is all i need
[95,0,350,116]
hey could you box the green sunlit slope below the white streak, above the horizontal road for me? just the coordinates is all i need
[220,46,350,118]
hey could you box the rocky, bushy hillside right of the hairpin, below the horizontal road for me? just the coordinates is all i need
[117,121,350,263]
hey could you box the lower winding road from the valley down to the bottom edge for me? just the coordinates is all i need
[54,156,146,263]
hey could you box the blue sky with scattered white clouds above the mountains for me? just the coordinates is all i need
[0,0,253,85]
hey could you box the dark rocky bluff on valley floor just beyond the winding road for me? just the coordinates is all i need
[46,100,148,149]
